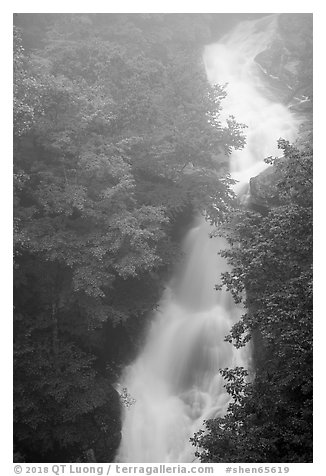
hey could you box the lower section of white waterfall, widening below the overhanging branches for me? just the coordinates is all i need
[118,220,244,463]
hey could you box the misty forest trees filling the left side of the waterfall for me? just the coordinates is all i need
[14,14,245,462]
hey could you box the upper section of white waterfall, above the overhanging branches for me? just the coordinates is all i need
[204,14,298,191]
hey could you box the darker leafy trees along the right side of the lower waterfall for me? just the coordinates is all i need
[192,139,313,463]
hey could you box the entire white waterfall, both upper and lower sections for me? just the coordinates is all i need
[117,15,297,463]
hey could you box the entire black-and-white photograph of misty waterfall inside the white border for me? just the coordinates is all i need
[9,2,316,476]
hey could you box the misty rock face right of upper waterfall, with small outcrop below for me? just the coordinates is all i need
[248,13,313,209]
